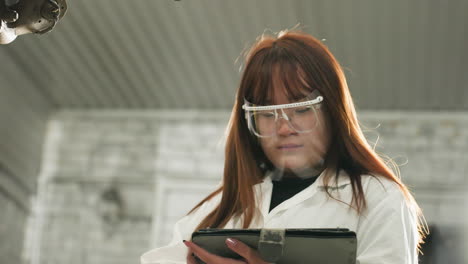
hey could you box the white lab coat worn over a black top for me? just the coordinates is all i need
[141,172,418,264]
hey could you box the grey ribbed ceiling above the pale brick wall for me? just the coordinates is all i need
[0,0,468,111]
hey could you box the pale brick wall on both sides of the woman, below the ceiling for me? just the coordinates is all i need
[22,111,468,264]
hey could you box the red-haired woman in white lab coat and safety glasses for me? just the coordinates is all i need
[141,31,422,264]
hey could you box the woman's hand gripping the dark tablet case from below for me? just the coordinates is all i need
[184,238,267,264]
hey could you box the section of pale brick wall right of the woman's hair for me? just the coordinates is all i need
[361,112,468,232]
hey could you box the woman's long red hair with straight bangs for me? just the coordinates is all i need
[190,31,424,245]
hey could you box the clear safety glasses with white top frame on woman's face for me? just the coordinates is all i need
[242,90,323,137]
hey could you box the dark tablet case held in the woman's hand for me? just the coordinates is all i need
[192,228,357,264]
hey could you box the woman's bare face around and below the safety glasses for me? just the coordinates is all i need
[259,89,330,172]
